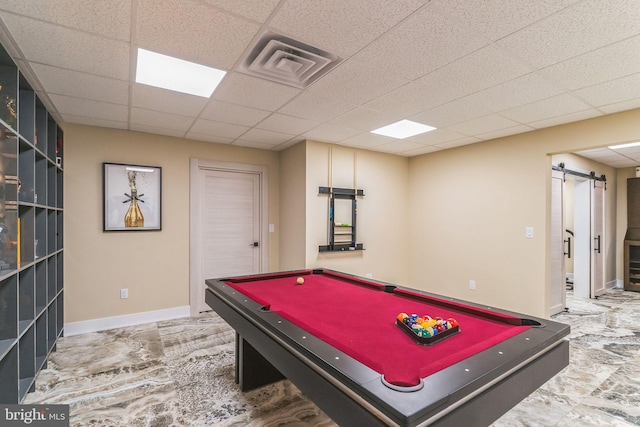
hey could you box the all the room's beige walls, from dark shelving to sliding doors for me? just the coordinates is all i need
[64,110,640,322]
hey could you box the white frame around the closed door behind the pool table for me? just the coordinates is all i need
[189,158,269,316]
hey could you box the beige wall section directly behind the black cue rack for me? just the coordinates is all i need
[305,141,409,284]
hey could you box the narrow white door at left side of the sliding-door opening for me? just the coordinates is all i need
[549,170,566,315]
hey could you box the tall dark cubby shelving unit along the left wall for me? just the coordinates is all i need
[0,40,64,404]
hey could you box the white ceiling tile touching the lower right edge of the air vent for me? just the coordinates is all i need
[307,60,407,105]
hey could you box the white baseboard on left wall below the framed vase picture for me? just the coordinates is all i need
[64,305,190,337]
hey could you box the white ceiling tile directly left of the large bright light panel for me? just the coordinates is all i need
[2,14,130,80]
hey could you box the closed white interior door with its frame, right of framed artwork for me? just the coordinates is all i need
[190,159,268,314]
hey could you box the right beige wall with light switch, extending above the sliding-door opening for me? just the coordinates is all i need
[409,110,640,317]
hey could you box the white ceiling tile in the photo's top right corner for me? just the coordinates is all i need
[498,0,640,68]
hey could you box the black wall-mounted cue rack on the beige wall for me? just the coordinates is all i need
[318,187,364,252]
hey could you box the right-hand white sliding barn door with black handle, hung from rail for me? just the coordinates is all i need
[590,181,605,298]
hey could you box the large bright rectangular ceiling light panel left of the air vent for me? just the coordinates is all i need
[136,49,227,98]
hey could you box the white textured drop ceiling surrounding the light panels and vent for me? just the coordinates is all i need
[0,0,640,167]
